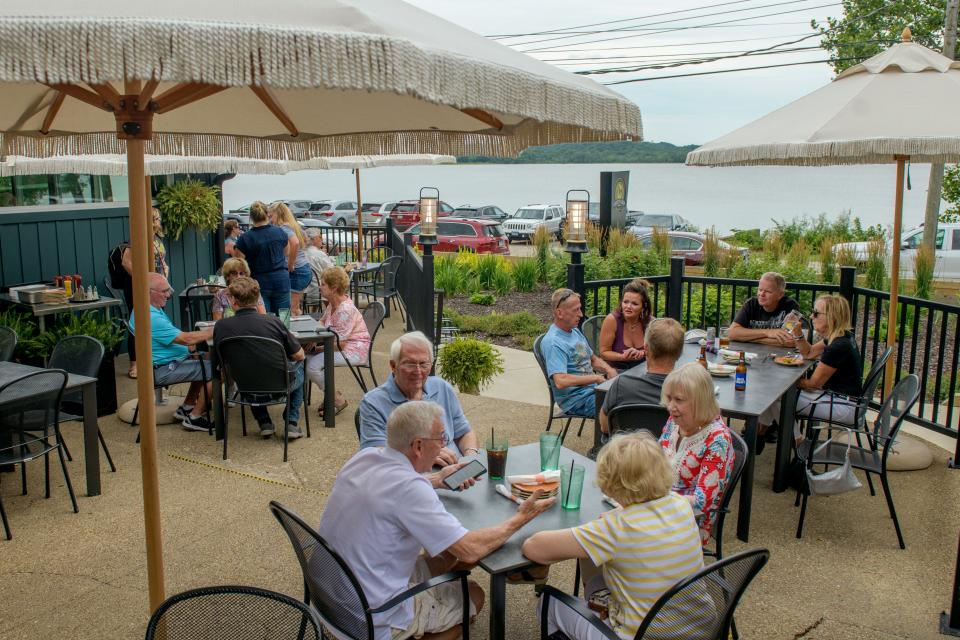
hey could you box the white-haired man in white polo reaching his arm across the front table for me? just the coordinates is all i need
[320,401,554,640]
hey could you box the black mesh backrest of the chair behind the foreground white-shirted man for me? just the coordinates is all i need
[270,500,374,640]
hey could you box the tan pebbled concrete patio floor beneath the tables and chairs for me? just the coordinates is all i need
[0,317,960,640]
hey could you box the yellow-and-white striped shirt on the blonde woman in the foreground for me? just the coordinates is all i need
[572,493,706,640]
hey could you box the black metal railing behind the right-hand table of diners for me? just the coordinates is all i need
[579,258,960,438]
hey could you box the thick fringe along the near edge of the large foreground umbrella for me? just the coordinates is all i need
[0,16,642,139]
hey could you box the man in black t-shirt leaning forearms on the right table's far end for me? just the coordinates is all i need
[730,271,800,347]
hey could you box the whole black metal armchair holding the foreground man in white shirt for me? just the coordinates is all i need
[270,500,470,640]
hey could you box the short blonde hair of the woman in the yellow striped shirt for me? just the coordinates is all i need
[597,430,673,506]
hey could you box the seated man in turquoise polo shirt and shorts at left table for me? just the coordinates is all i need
[130,273,213,431]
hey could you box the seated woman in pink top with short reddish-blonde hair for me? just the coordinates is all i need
[307,267,370,413]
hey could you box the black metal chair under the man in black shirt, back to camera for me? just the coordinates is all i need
[216,336,310,462]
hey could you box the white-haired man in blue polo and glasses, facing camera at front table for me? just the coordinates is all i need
[360,331,480,467]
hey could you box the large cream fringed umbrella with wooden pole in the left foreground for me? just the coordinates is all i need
[0,0,641,608]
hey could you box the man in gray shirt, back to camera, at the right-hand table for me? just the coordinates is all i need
[600,318,683,434]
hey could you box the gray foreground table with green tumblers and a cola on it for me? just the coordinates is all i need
[439,443,611,640]
